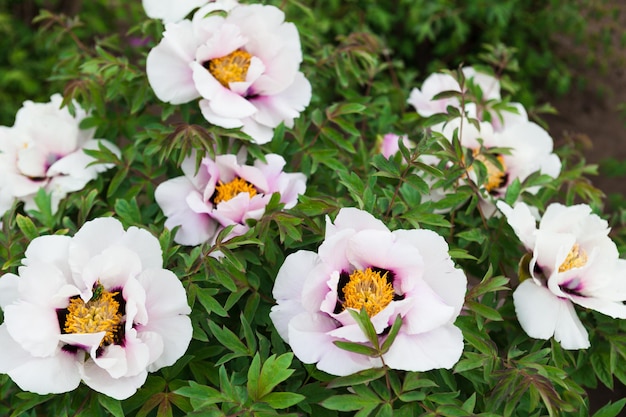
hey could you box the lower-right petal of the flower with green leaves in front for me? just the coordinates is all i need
[384,324,463,372]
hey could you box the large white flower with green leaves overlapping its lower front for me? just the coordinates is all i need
[270,208,467,375]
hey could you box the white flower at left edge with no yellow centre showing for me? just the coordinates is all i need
[0,94,119,213]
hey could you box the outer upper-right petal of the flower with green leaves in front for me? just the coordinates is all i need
[392,229,467,317]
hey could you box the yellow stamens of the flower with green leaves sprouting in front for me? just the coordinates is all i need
[343,268,393,317]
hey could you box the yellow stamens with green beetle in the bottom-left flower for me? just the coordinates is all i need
[63,289,122,346]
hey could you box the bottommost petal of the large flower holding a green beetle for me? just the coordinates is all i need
[80,360,148,400]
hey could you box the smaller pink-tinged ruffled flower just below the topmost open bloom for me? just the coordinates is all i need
[154,154,306,246]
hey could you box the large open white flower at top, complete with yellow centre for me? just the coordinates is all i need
[147,4,311,144]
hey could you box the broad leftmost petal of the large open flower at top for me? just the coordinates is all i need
[146,20,200,104]
